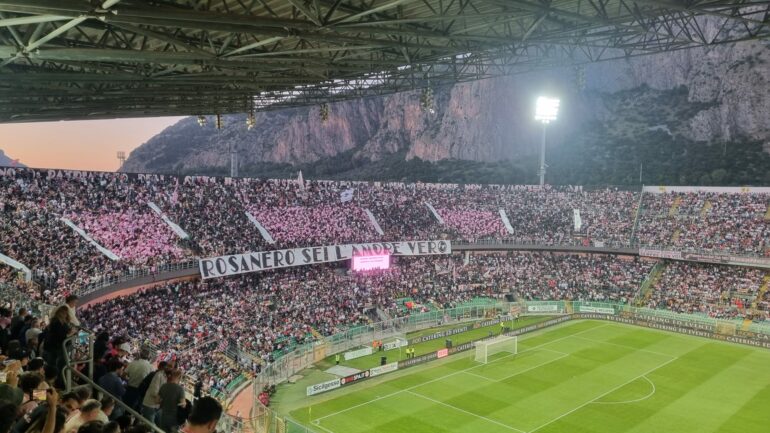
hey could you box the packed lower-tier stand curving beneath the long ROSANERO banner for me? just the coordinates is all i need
[81,253,651,384]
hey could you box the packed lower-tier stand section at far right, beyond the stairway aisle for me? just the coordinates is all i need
[647,262,770,319]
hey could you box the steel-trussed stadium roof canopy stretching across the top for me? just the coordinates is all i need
[0,0,770,122]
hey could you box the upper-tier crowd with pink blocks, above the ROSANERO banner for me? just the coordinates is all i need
[0,169,770,301]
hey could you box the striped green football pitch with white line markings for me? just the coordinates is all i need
[291,321,770,433]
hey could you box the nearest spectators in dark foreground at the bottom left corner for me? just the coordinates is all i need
[0,296,223,433]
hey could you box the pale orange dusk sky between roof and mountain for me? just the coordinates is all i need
[0,117,182,171]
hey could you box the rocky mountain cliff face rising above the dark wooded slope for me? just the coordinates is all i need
[123,41,770,183]
